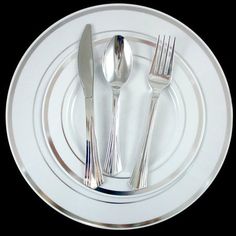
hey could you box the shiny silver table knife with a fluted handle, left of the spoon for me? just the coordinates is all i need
[78,24,104,189]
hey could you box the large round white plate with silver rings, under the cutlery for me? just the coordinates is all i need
[6,4,232,229]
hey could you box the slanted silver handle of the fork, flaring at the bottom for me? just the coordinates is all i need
[130,95,159,190]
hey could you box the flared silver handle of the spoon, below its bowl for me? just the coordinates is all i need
[104,89,122,176]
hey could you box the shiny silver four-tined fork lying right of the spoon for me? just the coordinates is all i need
[129,36,175,190]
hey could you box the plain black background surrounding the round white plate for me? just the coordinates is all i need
[0,0,236,235]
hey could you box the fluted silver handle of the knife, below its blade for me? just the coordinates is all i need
[84,98,104,189]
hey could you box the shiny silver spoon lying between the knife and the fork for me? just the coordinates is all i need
[102,35,133,176]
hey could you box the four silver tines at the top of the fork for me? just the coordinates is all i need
[150,35,176,77]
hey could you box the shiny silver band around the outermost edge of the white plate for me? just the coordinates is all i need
[5,4,233,230]
